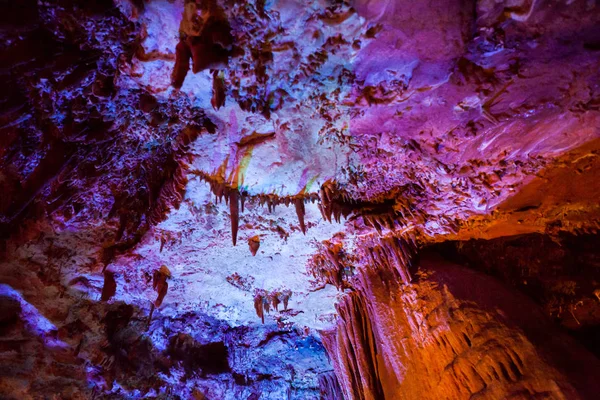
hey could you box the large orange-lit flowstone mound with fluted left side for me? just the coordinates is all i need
[323,236,600,399]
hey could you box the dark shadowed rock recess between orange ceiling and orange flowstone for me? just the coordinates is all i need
[432,232,600,355]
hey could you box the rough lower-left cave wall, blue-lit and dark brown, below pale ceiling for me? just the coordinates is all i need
[0,284,337,400]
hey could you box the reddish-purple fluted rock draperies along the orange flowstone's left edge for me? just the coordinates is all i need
[321,233,416,399]
